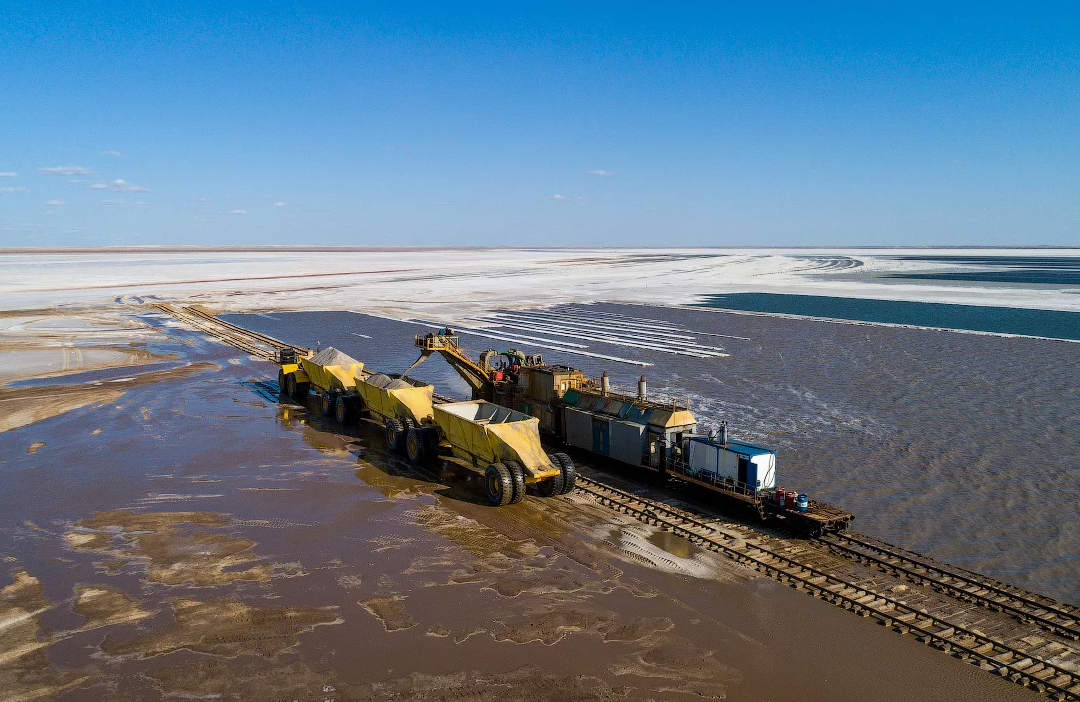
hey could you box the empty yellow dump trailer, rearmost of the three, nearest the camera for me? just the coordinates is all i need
[427,401,576,505]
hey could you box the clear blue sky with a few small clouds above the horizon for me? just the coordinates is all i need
[0,2,1080,246]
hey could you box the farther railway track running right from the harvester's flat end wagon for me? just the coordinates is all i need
[818,534,1080,640]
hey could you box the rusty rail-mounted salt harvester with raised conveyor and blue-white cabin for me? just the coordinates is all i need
[410,328,854,534]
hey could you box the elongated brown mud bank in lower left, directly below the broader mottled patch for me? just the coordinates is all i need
[102,597,341,658]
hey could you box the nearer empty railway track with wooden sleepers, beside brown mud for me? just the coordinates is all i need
[577,475,1080,700]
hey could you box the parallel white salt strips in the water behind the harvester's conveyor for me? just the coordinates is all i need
[409,308,750,366]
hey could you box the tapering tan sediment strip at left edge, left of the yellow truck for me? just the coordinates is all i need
[0,362,218,433]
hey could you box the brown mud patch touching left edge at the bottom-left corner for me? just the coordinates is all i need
[0,570,91,702]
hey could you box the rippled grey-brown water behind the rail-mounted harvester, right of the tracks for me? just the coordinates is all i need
[232,305,1080,604]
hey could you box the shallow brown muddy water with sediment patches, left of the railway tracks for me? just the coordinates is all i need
[0,315,1039,701]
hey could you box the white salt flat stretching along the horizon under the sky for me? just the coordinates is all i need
[6,247,1080,319]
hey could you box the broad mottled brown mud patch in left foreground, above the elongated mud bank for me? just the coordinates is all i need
[65,510,273,586]
